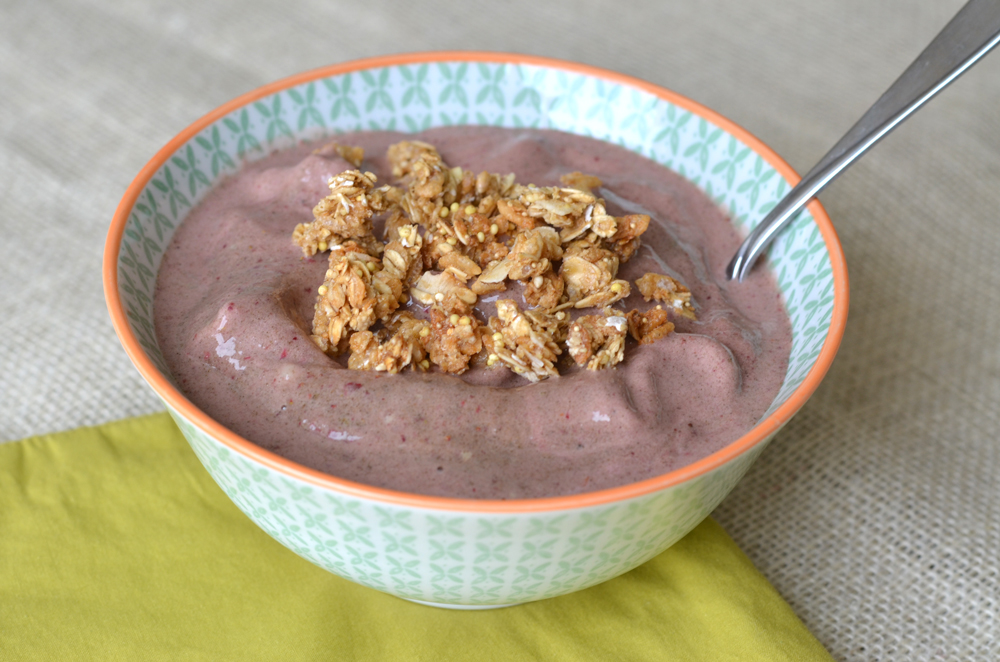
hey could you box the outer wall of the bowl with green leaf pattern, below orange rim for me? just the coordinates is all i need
[170,409,766,605]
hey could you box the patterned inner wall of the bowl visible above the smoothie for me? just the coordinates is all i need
[109,54,846,500]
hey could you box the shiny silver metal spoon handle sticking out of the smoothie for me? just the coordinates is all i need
[726,0,1000,281]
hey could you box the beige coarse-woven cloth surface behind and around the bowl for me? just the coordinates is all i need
[0,0,1000,660]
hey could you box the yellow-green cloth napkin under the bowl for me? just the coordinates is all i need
[0,414,830,662]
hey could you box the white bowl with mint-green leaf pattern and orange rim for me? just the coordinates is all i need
[104,52,847,608]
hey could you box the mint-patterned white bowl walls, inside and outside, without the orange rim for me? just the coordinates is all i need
[118,61,833,605]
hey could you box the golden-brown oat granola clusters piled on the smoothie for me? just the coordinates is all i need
[292,140,695,382]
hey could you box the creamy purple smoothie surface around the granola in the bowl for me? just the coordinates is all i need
[154,127,791,499]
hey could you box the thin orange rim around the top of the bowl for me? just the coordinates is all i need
[103,51,848,514]
